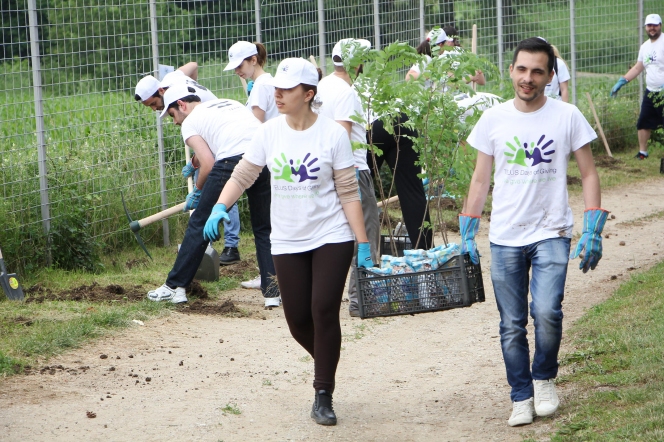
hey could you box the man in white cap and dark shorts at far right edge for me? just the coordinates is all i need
[611,14,664,160]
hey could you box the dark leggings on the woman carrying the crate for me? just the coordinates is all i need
[272,241,354,391]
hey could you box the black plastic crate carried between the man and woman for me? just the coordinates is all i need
[356,254,484,319]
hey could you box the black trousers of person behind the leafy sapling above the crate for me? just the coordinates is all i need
[367,114,433,249]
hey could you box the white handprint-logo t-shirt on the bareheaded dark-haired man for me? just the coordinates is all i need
[467,99,597,247]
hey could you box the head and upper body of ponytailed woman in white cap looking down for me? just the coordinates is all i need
[224,41,279,123]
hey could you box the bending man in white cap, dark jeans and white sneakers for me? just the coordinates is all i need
[148,83,279,307]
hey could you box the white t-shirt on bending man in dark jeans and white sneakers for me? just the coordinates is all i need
[182,98,261,161]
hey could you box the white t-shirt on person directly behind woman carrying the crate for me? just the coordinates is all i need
[318,74,369,170]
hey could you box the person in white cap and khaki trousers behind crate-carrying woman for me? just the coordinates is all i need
[318,38,380,317]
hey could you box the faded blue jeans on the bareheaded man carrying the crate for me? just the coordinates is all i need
[491,238,571,401]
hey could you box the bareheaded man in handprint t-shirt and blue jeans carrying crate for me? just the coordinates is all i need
[459,37,608,426]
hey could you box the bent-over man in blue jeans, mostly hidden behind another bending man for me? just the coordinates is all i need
[134,61,240,265]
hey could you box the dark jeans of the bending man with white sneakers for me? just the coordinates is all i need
[166,156,279,297]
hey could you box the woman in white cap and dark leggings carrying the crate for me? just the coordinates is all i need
[205,58,373,425]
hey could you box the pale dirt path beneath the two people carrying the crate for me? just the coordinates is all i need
[0,178,664,442]
